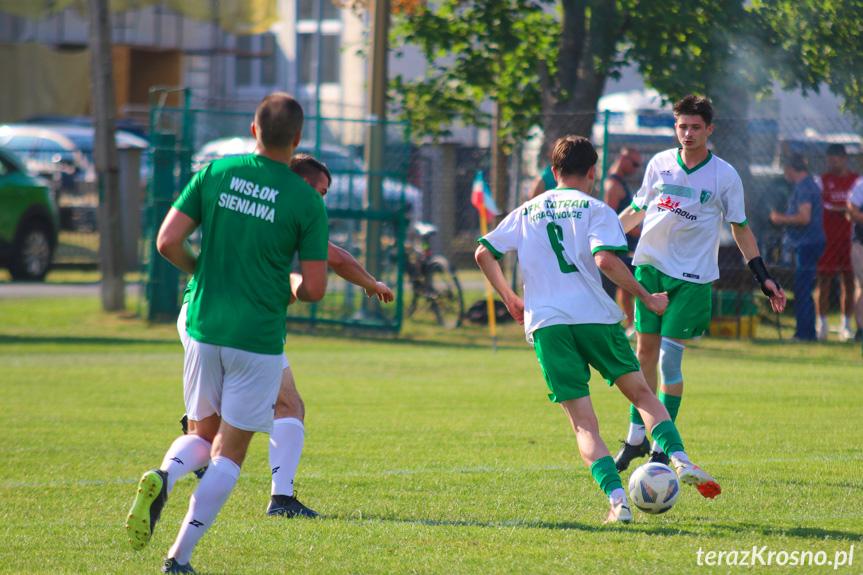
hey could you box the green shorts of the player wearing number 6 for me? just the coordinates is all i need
[533,323,641,403]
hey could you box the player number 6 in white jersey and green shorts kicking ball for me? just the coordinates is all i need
[476,136,721,523]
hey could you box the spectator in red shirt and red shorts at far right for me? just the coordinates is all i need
[815,144,859,341]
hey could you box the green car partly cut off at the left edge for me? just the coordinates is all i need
[0,147,59,281]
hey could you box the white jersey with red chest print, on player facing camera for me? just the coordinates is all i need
[632,148,746,284]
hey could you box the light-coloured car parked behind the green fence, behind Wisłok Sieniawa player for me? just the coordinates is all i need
[192,137,422,220]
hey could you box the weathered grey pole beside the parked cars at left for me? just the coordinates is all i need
[88,0,126,311]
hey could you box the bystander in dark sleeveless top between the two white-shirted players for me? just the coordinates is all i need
[602,148,641,337]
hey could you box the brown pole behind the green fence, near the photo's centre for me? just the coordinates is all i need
[366,0,390,311]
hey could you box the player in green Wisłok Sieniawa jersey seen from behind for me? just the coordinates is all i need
[126,93,327,573]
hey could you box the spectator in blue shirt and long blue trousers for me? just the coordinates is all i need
[770,152,826,341]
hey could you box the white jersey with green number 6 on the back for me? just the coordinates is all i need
[480,188,627,343]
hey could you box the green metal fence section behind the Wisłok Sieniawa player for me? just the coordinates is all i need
[143,91,412,332]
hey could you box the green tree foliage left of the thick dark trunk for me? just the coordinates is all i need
[392,0,557,144]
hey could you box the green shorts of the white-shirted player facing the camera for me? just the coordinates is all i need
[635,266,711,339]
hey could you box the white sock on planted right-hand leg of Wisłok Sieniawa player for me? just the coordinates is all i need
[168,456,240,565]
